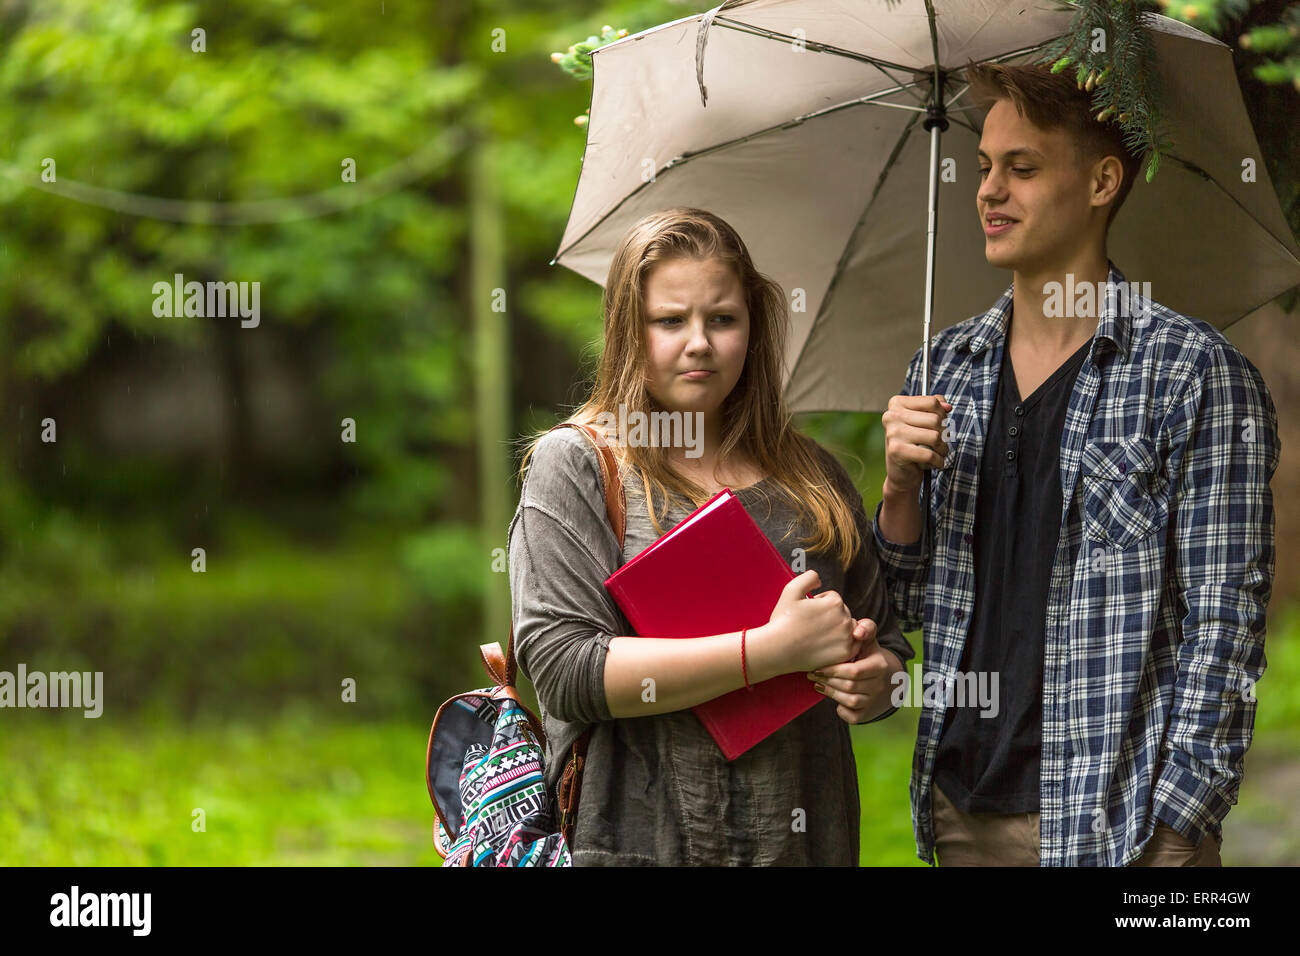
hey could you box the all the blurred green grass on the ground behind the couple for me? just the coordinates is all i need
[10,617,1300,866]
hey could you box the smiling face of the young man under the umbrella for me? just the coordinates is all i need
[975,99,1092,273]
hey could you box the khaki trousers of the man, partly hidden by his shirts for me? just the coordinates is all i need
[930,784,1223,866]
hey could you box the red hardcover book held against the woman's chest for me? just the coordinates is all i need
[605,488,826,760]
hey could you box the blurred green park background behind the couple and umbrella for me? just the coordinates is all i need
[0,0,1300,865]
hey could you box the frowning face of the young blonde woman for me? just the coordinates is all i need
[645,259,749,415]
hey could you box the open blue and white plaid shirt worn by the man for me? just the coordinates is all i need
[872,263,1279,866]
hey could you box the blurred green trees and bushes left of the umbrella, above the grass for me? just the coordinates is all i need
[0,0,680,714]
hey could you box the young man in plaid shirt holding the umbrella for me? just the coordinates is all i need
[875,66,1278,866]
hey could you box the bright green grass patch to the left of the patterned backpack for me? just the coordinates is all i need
[0,714,438,866]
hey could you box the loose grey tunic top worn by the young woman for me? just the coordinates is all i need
[508,428,913,866]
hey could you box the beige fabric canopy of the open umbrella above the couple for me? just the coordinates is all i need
[554,0,1300,411]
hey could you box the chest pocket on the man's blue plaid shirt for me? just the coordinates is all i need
[1079,438,1167,550]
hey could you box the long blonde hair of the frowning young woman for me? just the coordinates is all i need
[519,207,861,568]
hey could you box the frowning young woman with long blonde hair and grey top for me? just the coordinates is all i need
[510,208,913,866]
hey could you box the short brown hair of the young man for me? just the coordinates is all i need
[966,64,1141,229]
